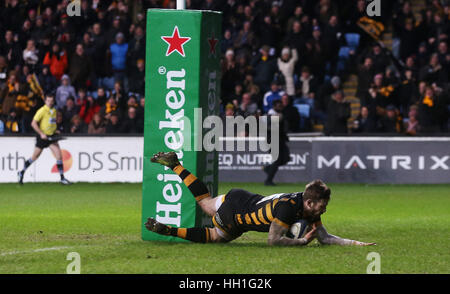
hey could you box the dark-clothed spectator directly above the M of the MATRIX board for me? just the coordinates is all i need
[326,91,351,135]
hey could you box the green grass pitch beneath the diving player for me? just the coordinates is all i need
[0,183,450,274]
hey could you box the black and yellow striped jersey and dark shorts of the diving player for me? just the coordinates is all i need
[213,189,303,235]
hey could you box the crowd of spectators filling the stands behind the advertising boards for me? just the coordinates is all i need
[0,0,450,135]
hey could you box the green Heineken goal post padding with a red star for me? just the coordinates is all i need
[141,9,222,242]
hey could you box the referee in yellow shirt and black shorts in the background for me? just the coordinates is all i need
[18,94,71,185]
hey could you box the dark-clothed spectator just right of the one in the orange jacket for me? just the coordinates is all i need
[69,44,93,89]
